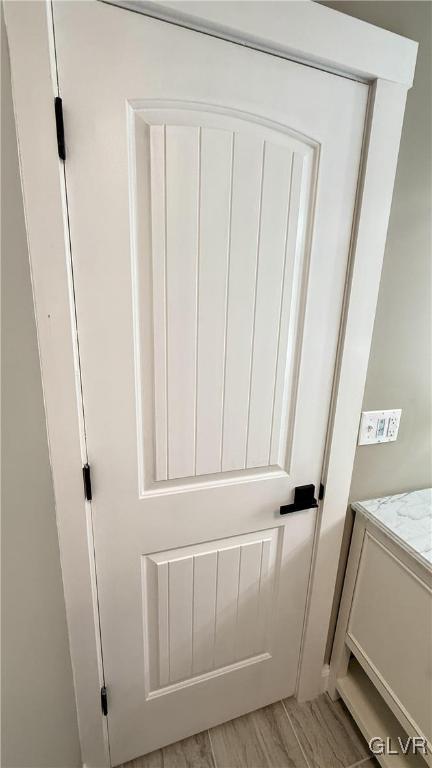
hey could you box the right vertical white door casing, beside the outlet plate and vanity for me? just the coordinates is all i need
[297,80,407,699]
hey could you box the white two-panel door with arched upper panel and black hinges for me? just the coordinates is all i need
[54,2,367,765]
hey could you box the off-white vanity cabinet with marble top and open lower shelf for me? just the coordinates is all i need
[329,489,432,767]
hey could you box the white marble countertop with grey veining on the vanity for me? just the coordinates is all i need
[351,488,432,568]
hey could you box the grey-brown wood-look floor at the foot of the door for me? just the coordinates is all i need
[120,694,377,768]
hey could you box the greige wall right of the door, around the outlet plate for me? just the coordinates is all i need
[323,0,432,658]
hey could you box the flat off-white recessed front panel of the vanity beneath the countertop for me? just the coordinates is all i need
[348,532,432,740]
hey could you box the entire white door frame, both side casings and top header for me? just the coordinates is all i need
[5,0,417,768]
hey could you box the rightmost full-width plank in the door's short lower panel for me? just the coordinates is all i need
[236,541,262,659]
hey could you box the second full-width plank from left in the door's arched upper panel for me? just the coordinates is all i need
[196,128,233,475]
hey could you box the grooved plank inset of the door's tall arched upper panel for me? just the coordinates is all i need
[150,125,310,480]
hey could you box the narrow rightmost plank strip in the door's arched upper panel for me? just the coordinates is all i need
[269,154,303,466]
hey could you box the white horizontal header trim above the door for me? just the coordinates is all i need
[101,0,418,87]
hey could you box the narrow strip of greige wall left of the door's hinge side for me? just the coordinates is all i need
[1,12,81,768]
